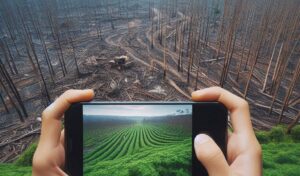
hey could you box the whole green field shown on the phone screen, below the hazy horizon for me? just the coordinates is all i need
[84,123,192,176]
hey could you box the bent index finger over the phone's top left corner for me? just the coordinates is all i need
[40,90,94,148]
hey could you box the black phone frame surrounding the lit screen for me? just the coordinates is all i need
[64,102,228,176]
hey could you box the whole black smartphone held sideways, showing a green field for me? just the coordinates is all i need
[64,102,227,176]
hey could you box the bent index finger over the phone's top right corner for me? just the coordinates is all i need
[192,87,253,134]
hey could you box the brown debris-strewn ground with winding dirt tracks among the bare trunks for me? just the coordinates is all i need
[0,2,300,162]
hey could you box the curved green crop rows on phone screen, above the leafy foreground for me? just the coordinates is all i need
[84,124,188,164]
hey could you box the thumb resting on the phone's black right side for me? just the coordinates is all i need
[194,134,229,176]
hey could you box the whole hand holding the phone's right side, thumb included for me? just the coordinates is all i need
[192,87,262,176]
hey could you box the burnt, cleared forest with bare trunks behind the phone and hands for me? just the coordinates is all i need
[0,0,300,165]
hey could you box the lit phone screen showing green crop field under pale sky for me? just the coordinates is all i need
[82,104,193,176]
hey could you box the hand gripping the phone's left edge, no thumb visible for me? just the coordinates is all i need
[32,89,94,176]
